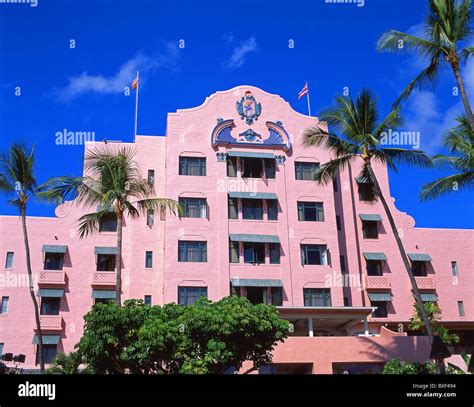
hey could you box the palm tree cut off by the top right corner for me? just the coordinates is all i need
[377,0,474,130]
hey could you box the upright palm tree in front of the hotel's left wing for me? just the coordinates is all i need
[46,147,181,306]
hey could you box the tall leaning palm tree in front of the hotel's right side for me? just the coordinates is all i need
[303,90,433,341]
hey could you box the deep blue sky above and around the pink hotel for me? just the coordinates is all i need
[0,0,474,228]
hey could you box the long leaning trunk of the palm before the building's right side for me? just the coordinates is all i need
[367,163,433,343]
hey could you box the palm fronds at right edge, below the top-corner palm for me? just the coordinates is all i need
[420,116,474,201]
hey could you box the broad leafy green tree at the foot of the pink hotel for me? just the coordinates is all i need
[76,297,289,374]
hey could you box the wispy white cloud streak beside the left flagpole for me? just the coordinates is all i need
[54,43,178,101]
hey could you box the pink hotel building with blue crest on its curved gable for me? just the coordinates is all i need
[0,86,474,373]
